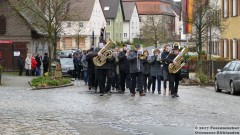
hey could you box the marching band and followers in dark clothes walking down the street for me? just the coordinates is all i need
[73,44,180,98]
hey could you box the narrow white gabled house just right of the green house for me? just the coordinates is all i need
[123,2,140,42]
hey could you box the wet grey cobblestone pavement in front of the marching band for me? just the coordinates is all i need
[0,76,240,135]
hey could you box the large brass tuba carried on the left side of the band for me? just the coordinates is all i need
[93,38,116,66]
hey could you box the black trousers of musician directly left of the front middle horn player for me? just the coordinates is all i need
[120,71,131,92]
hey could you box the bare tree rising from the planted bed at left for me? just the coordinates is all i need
[9,0,69,73]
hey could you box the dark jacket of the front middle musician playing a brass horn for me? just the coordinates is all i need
[127,50,143,73]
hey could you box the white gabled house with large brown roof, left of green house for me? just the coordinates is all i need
[59,0,106,50]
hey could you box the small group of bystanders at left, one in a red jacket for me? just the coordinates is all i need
[18,53,49,76]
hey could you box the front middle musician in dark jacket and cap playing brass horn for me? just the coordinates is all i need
[127,44,146,96]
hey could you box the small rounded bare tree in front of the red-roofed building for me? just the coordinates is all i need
[141,15,172,48]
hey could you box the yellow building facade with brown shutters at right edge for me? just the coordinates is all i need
[219,0,240,59]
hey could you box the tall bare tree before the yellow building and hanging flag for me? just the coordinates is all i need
[183,0,227,73]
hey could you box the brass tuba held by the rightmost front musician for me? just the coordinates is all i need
[168,47,188,74]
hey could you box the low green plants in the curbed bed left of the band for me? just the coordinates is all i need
[31,76,71,87]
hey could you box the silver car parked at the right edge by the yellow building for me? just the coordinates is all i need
[215,61,240,95]
